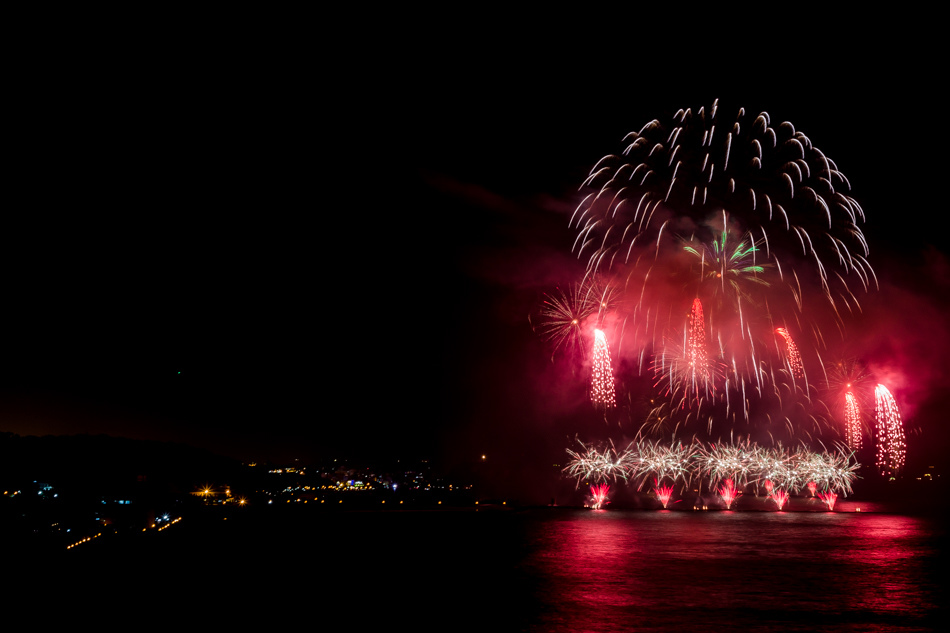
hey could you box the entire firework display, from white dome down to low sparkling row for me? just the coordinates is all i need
[532,101,916,509]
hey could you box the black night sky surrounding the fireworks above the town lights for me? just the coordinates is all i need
[0,25,950,498]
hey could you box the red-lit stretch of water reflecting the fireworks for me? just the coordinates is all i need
[523,511,946,631]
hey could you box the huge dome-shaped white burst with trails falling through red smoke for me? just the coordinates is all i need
[570,102,877,439]
